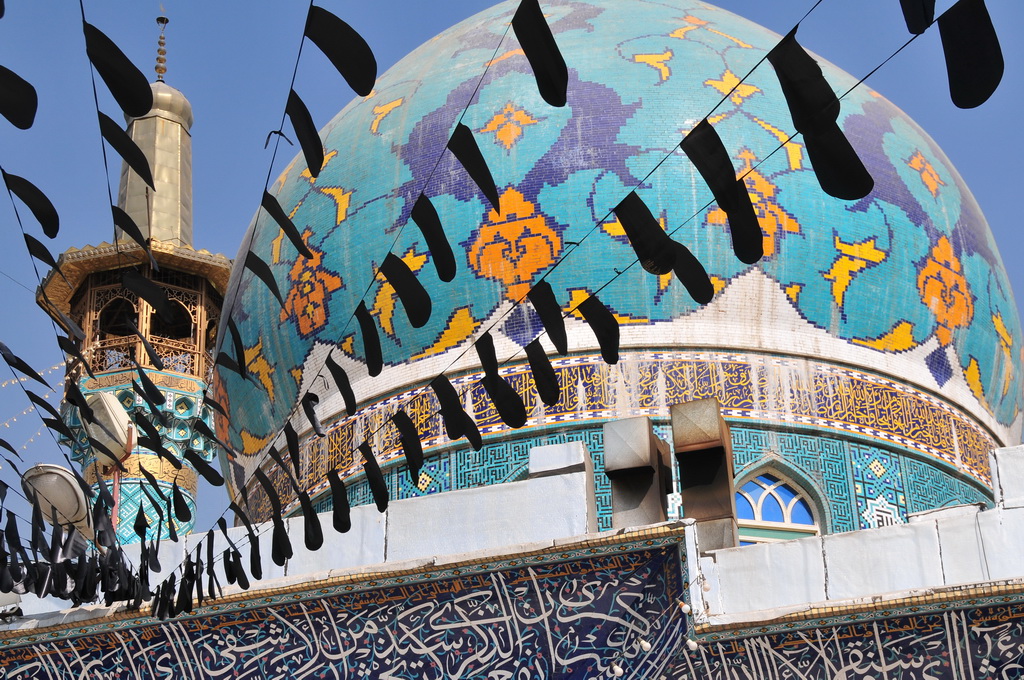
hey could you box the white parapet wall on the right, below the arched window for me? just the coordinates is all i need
[687,447,1024,626]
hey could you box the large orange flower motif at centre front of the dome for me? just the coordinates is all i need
[467,187,562,301]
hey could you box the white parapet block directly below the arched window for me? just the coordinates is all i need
[712,537,825,613]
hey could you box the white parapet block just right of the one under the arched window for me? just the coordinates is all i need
[821,523,942,600]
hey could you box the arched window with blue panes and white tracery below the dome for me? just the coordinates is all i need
[736,472,820,546]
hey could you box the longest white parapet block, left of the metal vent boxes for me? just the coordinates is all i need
[386,472,597,562]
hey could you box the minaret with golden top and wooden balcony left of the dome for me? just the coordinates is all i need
[37,16,230,544]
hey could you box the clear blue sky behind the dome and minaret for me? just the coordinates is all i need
[0,0,1024,529]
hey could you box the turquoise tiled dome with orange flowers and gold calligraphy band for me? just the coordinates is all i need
[217,0,1022,529]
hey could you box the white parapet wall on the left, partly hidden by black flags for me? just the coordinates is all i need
[0,441,597,630]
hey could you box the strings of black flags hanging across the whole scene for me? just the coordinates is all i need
[0,0,1002,618]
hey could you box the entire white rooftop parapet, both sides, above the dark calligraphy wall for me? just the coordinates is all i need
[0,442,1024,644]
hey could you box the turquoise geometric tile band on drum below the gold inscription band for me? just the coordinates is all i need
[313,423,990,534]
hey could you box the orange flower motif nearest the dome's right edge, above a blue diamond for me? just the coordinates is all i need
[918,237,974,347]
